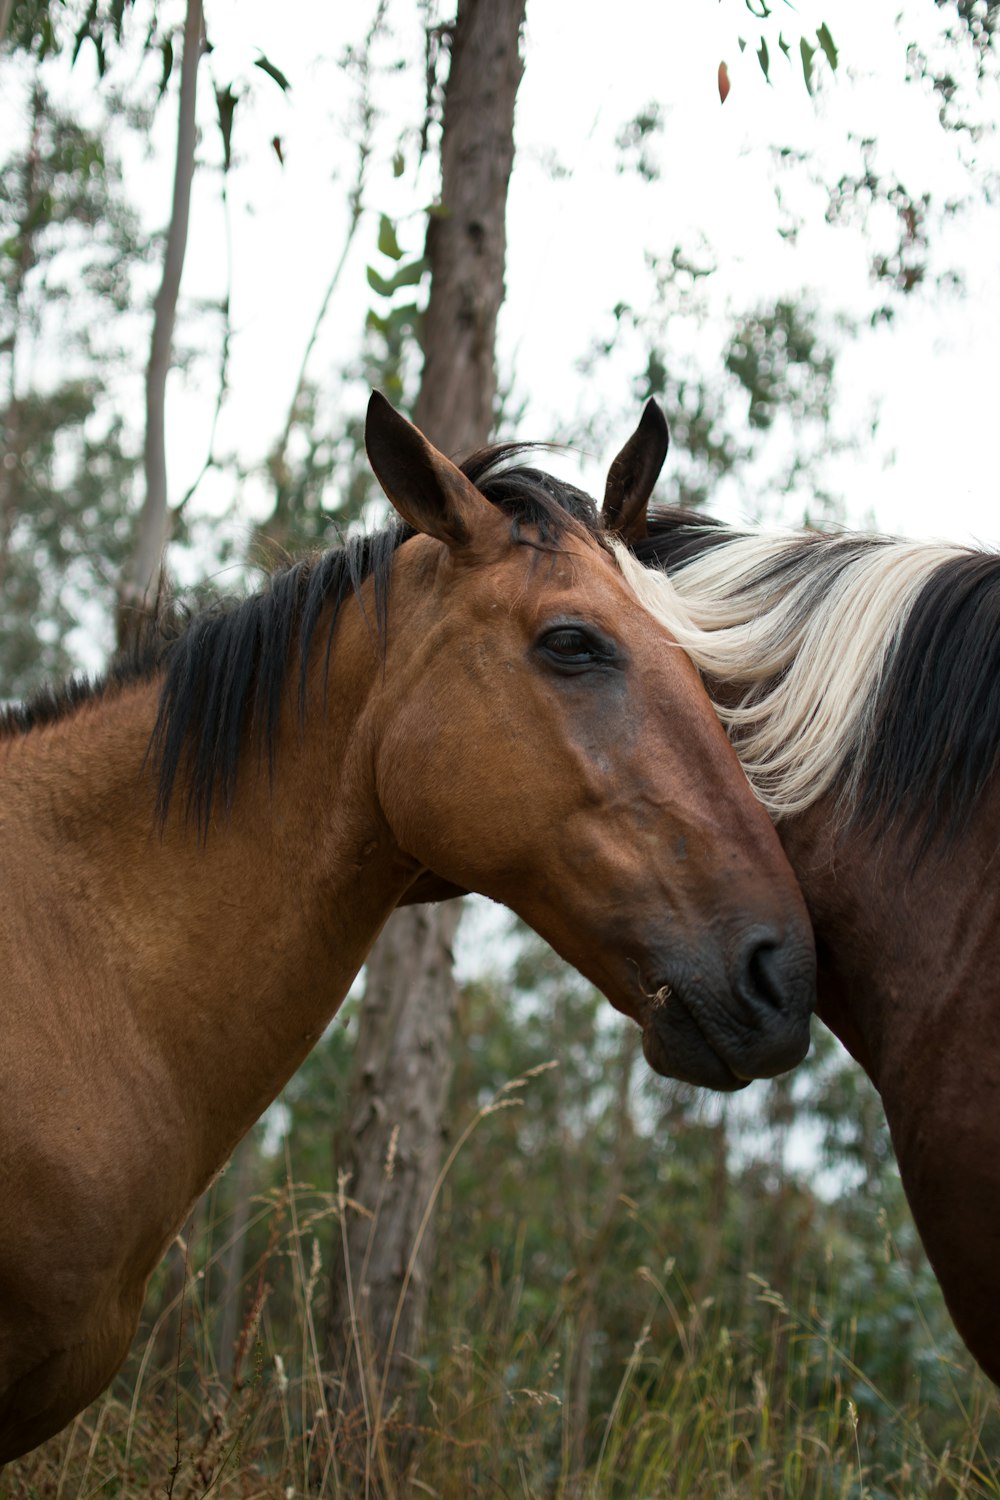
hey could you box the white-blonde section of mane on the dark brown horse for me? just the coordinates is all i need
[615,533,969,818]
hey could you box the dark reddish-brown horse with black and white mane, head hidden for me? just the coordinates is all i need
[609,438,1000,1383]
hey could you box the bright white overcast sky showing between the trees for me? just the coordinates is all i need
[7,0,1000,540]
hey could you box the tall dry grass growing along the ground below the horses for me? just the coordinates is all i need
[7,1076,1000,1500]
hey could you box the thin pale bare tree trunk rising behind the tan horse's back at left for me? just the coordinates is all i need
[118,0,205,647]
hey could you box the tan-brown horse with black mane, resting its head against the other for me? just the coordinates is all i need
[0,398,814,1463]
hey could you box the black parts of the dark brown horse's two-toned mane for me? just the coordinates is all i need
[633,507,1000,851]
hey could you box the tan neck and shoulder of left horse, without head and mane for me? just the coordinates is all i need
[0,594,412,1458]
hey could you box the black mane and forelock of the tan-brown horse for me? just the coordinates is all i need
[0,443,604,836]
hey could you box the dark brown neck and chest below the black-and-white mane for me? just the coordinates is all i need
[781,789,1000,1382]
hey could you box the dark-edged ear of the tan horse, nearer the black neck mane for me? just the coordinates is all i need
[364,390,489,548]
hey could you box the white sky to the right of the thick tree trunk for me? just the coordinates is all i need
[504,0,1000,539]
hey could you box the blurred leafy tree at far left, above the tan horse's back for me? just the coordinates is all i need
[0,77,145,696]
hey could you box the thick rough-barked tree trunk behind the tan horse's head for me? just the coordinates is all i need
[330,0,525,1443]
